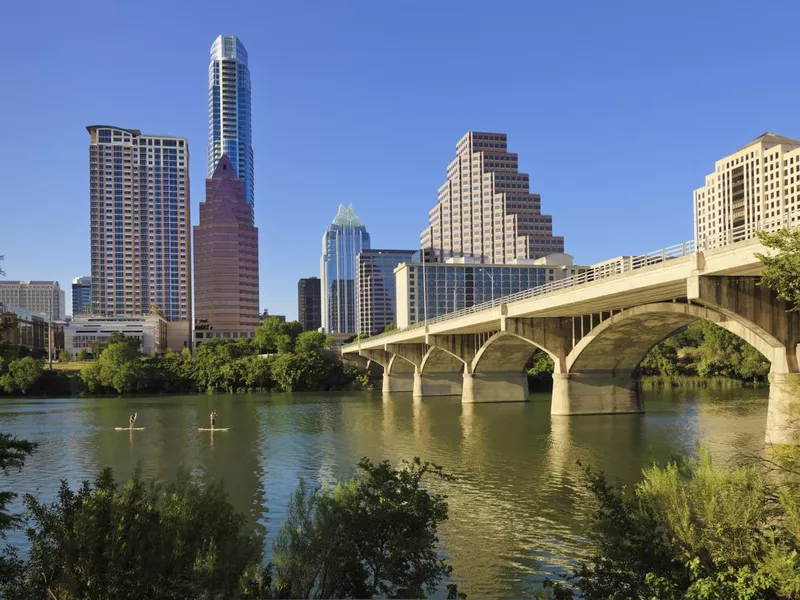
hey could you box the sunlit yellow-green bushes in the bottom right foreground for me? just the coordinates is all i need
[575,447,800,599]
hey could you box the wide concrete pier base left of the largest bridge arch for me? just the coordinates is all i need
[550,371,644,415]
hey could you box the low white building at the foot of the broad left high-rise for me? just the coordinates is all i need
[64,314,172,356]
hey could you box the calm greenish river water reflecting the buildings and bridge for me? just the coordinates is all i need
[0,389,767,597]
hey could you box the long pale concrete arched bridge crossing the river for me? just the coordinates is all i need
[342,239,800,442]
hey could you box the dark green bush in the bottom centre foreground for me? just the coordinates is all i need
[273,458,457,598]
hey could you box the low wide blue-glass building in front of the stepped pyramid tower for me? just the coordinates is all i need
[395,253,588,327]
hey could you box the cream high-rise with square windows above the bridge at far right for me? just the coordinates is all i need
[694,132,800,250]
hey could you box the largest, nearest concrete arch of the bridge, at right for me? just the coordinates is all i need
[566,302,790,374]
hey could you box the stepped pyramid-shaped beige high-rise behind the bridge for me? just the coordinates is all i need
[421,131,564,264]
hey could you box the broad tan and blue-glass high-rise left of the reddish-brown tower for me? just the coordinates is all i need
[87,125,192,350]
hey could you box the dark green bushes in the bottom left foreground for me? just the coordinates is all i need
[4,469,263,600]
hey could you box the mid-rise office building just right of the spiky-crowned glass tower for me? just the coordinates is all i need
[356,250,418,336]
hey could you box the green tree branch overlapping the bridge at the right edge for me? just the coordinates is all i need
[756,229,800,311]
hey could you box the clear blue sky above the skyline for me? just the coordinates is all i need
[0,0,800,317]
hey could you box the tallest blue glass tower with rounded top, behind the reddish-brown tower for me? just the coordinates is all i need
[207,35,255,216]
